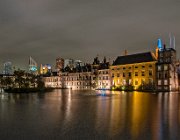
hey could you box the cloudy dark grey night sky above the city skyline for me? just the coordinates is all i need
[0,0,180,68]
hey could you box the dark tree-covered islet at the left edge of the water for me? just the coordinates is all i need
[0,69,50,93]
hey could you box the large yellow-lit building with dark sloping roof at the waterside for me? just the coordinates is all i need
[110,52,156,89]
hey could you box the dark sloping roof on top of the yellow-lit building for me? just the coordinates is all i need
[113,52,156,65]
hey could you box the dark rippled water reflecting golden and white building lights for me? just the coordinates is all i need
[0,90,180,140]
